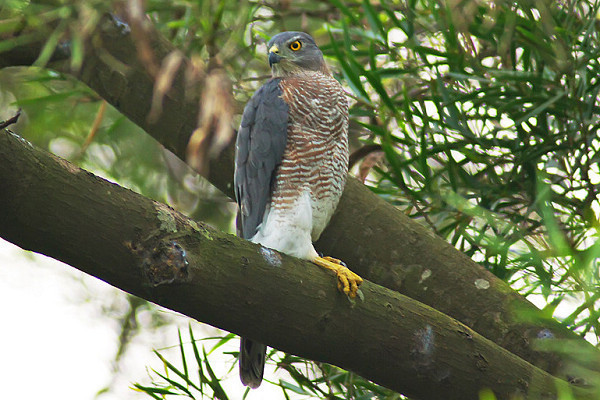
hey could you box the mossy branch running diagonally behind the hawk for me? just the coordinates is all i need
[0,12,600,386]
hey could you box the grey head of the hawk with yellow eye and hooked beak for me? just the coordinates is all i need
[267,31,329,76]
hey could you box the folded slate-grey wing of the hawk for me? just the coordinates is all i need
[234,79,289,239]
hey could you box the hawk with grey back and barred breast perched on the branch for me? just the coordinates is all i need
[234,32,362,388]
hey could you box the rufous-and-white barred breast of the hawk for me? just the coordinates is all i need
[271,73,348,240]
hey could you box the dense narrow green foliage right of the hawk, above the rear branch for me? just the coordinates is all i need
[324,1,600,337]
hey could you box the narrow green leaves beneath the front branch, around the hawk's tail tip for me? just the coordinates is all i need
[134,325,404,400]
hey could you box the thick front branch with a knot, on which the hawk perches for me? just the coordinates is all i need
[0,127,596,400]
